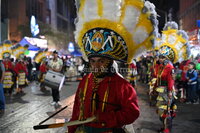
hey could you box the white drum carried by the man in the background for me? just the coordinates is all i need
[44,70,65,91]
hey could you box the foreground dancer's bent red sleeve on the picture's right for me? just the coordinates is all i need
[98,83,140,128]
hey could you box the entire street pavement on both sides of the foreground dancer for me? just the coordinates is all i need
[0,82,200,133]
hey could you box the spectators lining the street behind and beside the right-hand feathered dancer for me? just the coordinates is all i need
[136,56,200,104]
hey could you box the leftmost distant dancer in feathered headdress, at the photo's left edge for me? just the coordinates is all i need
[1,40,14,95]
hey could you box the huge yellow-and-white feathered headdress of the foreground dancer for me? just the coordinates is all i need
[75,0,158,62]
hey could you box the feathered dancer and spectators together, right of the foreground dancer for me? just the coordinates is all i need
[126,22,200,133]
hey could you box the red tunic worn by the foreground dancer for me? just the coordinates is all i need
[68,74,139,133]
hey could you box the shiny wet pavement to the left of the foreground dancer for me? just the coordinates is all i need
[0,82,78,133]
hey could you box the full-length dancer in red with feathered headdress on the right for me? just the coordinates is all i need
[156,22,190,133]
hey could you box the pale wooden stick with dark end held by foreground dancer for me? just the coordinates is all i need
[33,116,96,130]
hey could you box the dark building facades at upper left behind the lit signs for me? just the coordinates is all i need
[1,0,76,48]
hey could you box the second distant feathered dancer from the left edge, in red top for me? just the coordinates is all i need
[12,44,28,93]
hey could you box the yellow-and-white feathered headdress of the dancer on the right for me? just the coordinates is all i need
[159,22,190,62]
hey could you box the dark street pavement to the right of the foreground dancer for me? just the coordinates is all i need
[133,83,200,133]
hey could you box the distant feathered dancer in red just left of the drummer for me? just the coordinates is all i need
[34,49,48,91]
